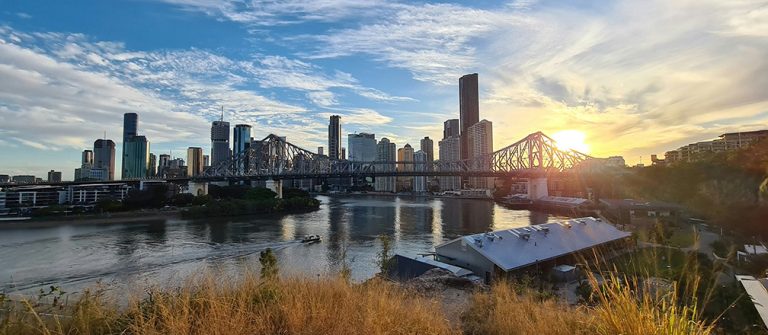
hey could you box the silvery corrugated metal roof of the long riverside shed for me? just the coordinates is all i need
[435,217,631,271]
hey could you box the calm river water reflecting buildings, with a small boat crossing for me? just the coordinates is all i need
[0,195,564,293]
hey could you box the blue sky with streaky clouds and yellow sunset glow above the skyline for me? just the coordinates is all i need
[0,0,768,179]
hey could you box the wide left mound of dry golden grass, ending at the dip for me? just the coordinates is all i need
[0,277,457,334]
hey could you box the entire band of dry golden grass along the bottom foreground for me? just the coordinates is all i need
[0,268,712,335]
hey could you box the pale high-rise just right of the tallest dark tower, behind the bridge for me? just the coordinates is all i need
[467,120,494,189]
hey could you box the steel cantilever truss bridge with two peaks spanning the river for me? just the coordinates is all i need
[198,132,594,182]
